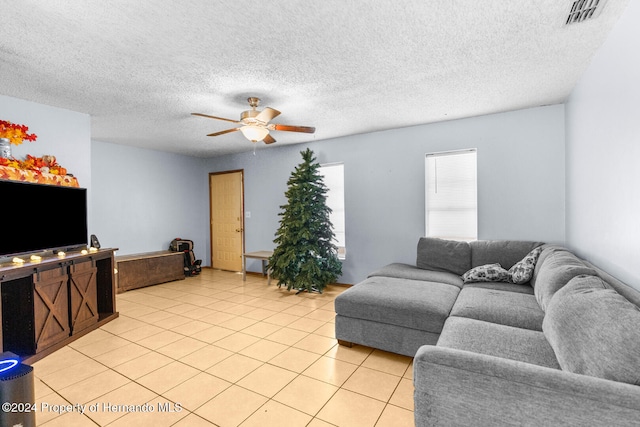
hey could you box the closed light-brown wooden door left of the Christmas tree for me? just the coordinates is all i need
[209,171,244,271]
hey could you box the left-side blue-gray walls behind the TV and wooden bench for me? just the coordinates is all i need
[0,95,209,257]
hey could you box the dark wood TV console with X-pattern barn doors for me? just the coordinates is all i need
[0,249,118,363]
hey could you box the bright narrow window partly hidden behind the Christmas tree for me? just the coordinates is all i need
[319,163,347,259]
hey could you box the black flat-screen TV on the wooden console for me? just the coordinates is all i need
[0,180,87,257]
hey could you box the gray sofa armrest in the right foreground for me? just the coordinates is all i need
[413,346,640,426]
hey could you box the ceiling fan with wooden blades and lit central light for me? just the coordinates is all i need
[191,97,316,144]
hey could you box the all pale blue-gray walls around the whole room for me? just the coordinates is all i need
[6,6,640,289]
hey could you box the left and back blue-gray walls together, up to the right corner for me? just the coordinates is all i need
[0,96,565,283]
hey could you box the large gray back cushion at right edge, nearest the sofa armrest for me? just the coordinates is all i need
[543,276,640,385]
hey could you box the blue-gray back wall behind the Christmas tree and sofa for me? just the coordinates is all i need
[205,105,565,283]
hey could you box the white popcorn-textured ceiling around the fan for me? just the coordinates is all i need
[0,0,628,157]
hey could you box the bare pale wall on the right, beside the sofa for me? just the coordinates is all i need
[566,1,640,289]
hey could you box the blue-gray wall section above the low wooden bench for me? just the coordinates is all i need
[91,141,209,264]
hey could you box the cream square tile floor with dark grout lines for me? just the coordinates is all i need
[33,269,414,427]
